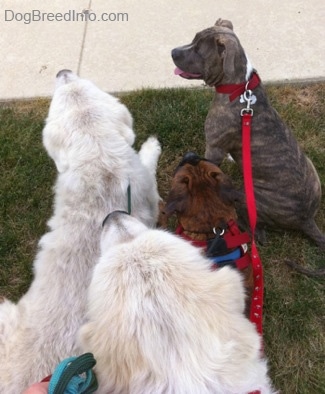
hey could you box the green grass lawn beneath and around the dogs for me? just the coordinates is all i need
[0,83,325,394]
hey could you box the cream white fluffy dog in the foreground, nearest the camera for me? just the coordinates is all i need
[79,212,273,394]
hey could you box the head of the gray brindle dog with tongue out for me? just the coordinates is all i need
[172,19,253,86]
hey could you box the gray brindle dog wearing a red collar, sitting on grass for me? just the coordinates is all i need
[172,19,325,249]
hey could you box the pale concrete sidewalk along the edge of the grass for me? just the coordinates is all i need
[0,0,325,99]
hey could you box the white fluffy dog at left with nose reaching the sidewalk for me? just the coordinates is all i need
[0,70,160,394]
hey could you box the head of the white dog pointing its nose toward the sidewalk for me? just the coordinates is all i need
[43,70,135,172]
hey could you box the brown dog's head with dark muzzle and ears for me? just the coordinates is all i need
[164,152,237,232]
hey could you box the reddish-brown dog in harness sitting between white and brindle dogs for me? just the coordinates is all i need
[163,152,253,315]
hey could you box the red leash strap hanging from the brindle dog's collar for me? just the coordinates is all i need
[241,111,264,335]
